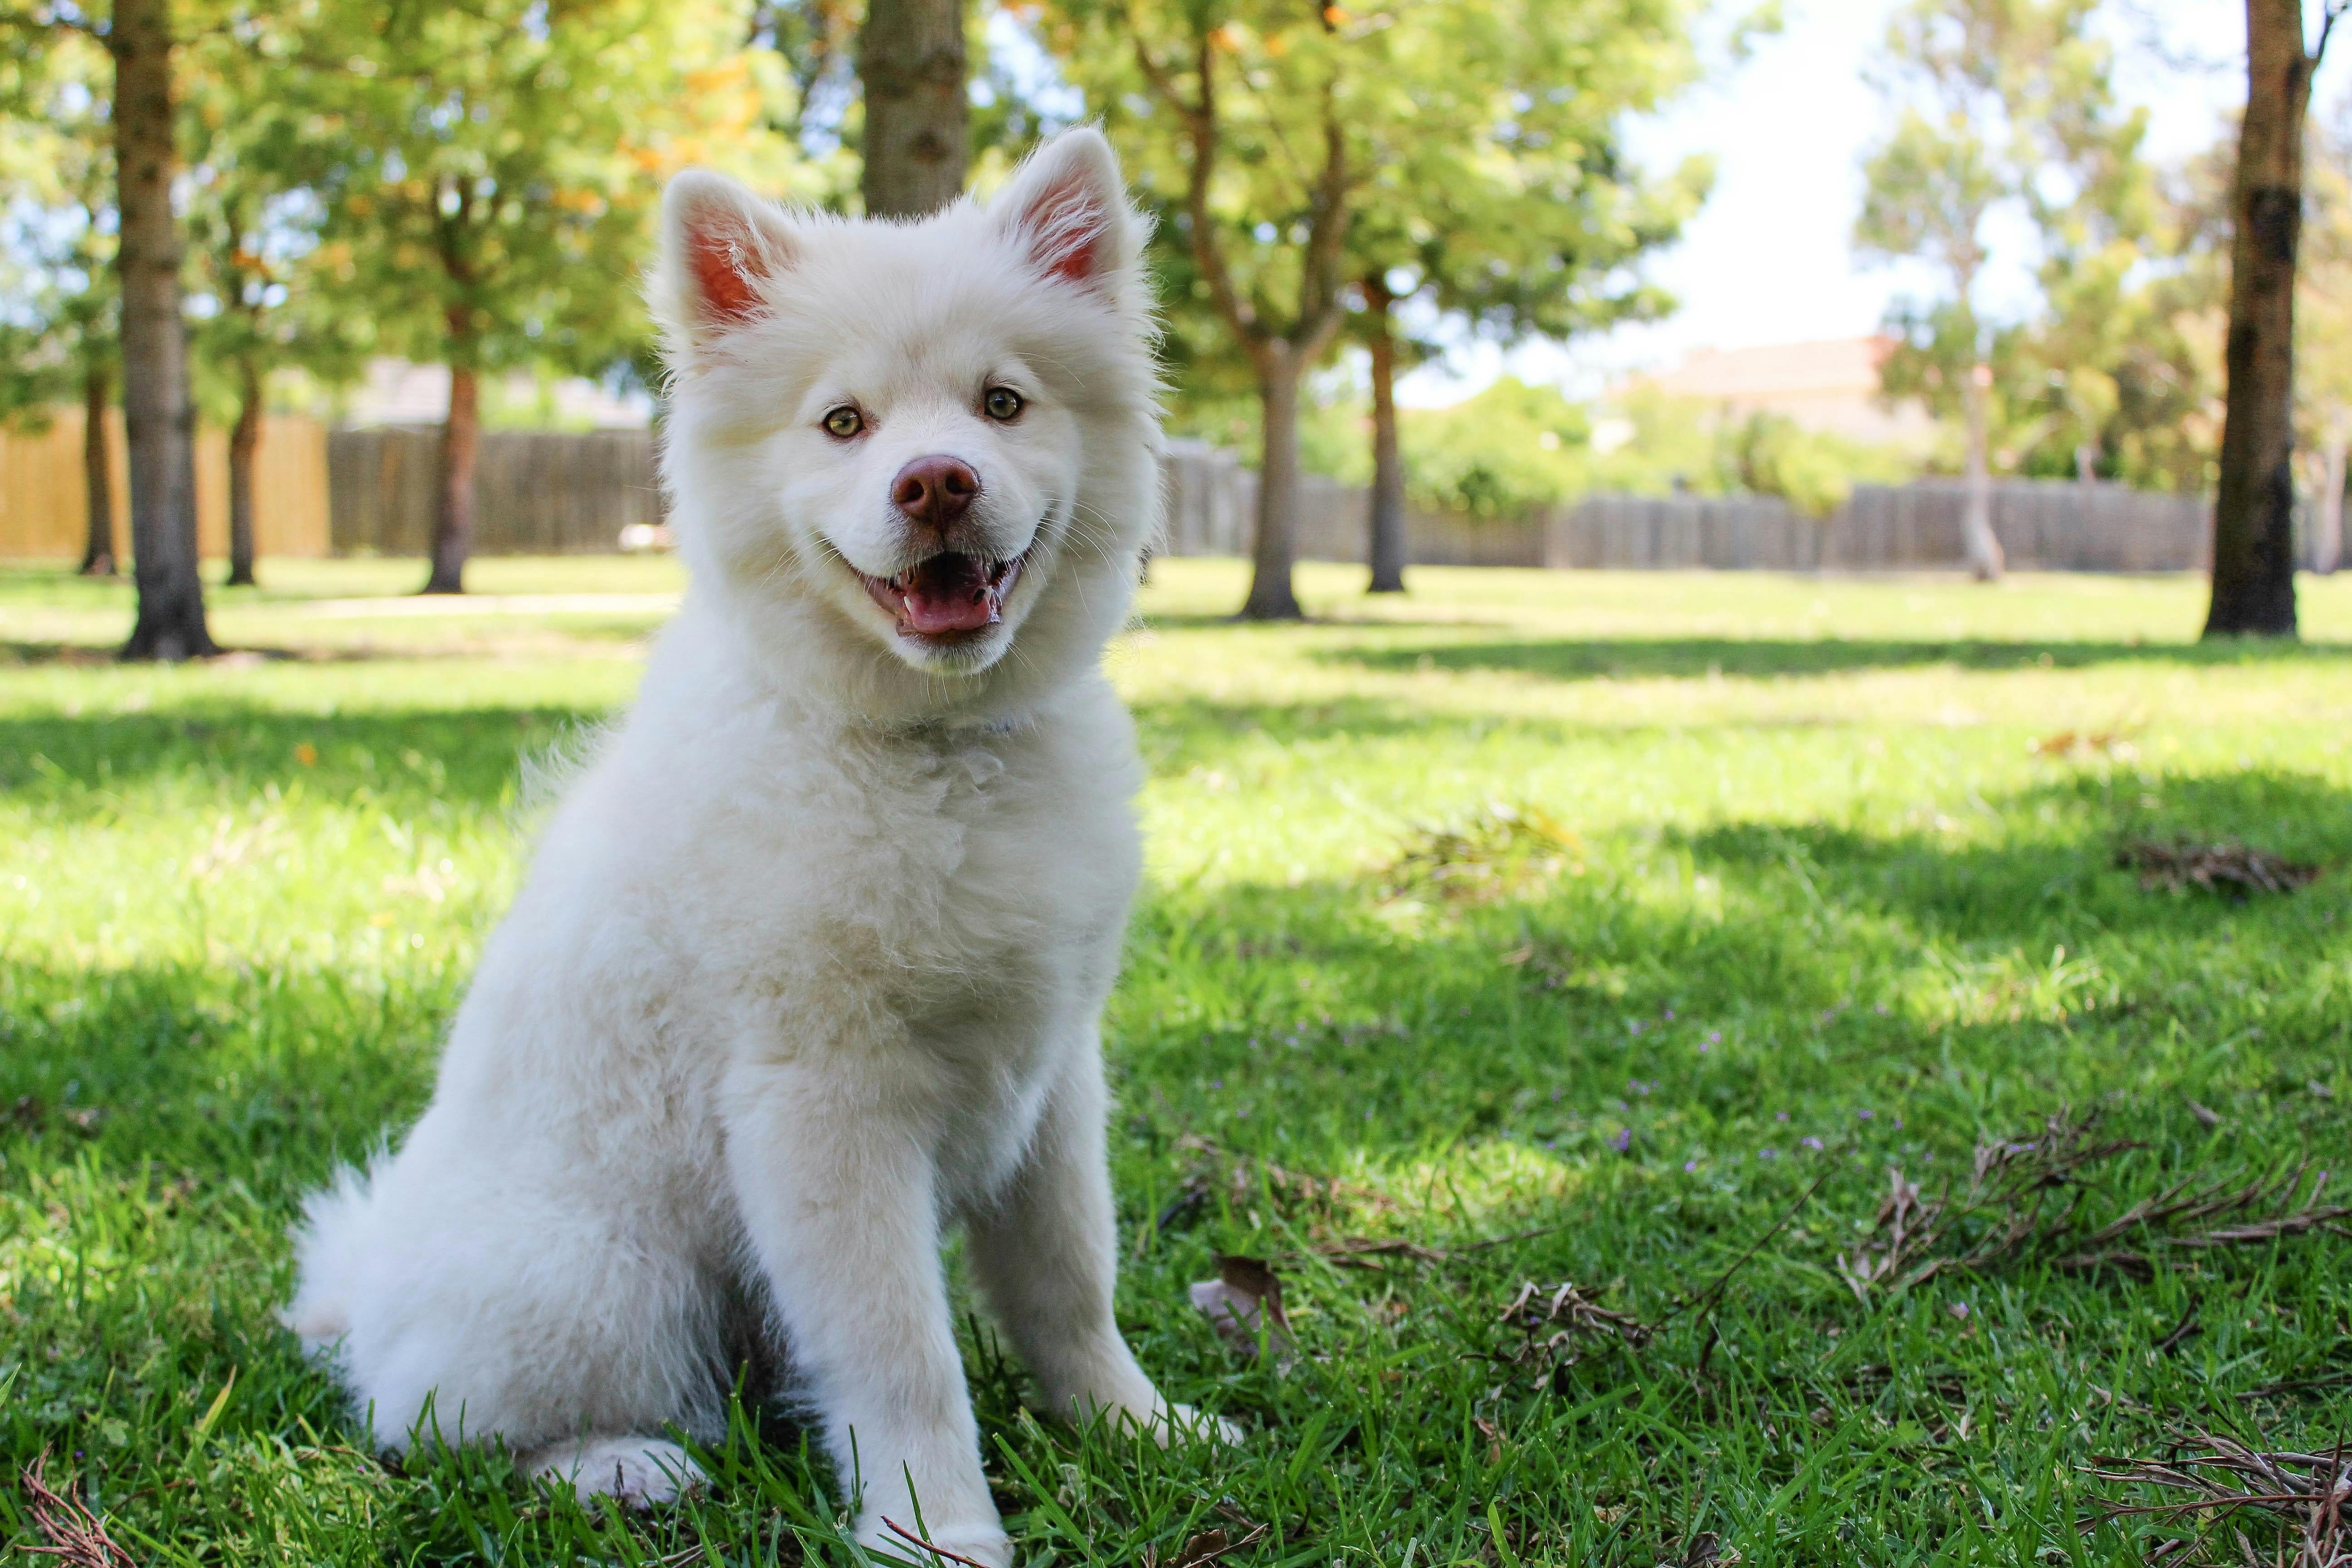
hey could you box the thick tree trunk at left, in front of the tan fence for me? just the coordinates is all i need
[106,0,219,658]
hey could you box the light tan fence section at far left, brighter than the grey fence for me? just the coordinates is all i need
[0,409,329,562]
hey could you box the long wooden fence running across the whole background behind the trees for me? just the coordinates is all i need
[0,421,2258,571]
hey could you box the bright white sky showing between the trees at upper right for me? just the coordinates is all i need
[1397,0,2352,407]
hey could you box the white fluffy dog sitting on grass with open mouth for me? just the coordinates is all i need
[289,129,1190,1563]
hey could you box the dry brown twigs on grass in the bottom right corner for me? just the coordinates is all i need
[2082,1431,2352,1568]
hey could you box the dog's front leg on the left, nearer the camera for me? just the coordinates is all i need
[727,1055,1011,1563]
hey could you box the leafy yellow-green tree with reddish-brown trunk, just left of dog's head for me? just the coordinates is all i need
[289,0,783,593]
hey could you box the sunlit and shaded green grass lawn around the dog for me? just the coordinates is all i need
[0,559,2352,1568]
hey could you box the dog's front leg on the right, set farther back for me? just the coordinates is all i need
[969,1039,1237,1443]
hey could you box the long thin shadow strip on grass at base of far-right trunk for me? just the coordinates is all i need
[1308,637,2352,682]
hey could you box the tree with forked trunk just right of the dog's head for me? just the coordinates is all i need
[1044,0,1392,621]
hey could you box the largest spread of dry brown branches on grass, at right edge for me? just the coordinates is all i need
[1837,1112,2352,1303]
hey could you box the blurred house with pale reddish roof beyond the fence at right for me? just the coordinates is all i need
[1639,336,1936,446]
